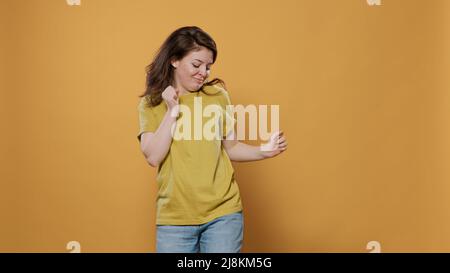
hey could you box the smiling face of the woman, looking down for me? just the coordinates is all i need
[172,46,213,92]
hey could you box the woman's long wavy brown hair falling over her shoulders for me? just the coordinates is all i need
[139,26,225,107]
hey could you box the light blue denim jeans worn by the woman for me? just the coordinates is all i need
[156,212,244,253]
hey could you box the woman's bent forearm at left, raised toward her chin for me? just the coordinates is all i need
[144,111,176,166]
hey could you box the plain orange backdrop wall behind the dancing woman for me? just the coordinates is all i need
[0,0,450,252]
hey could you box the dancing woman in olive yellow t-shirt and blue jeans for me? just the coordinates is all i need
[138,27,287,253]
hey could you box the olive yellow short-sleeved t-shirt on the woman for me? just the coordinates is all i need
[138,85,242,225]
